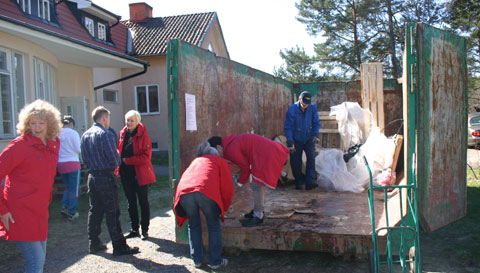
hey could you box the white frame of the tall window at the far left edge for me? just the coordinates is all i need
[0,47,25,139]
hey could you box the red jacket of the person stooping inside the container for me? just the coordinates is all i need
[222,134,288,189]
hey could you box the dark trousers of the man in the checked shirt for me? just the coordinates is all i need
[88,172,126,248]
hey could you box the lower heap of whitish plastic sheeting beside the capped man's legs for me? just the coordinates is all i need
[315,149,363,192]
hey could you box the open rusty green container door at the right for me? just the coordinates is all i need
[404,23,467,232]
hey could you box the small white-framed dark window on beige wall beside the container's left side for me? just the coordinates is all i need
[135,85,160,114]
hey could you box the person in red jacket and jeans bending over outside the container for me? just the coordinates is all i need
[173,141,233,269]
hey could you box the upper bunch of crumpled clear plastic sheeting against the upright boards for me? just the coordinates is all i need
[330,102,373,150]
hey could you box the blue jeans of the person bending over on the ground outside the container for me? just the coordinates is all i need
[180,192,222,265]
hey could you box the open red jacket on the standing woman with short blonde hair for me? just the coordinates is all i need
[115,123,157,186]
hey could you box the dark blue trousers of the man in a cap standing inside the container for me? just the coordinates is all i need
[290,139,316,185]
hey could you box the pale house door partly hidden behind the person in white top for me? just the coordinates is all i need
[60,96,88,136]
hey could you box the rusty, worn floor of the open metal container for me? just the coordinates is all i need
[216,175,405,256]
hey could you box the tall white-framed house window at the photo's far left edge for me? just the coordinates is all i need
[0,48,25,139]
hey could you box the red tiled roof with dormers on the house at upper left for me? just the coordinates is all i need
[0,0,127,54]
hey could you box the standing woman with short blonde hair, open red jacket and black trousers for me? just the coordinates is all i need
[117,110,156,240]
